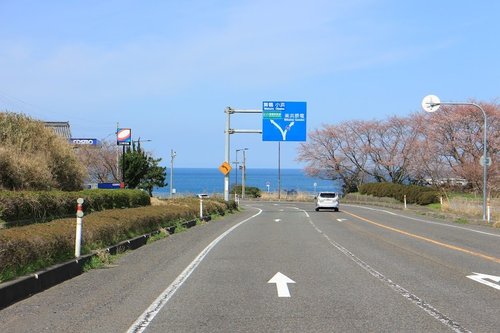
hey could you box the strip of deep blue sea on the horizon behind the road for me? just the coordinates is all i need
[153,168,341,197]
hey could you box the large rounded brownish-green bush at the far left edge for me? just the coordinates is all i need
[0,112,86,191]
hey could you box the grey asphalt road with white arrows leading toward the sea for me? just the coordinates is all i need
[0,202,500,332]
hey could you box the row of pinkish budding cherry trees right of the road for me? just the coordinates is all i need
[297,103,500,193]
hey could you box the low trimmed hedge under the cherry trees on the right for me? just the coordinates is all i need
[359,183,439,205]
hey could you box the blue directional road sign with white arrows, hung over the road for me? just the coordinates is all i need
[262,101,307,141]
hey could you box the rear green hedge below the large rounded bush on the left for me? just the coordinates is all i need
[0,190,150,226]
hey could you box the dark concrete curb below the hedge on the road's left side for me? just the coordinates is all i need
[0,216,211,310]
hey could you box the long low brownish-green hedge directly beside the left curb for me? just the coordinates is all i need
[0,199,237,282]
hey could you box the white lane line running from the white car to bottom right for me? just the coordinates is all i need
[298,208,470,333]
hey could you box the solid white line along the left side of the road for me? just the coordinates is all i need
[127,208,262,333]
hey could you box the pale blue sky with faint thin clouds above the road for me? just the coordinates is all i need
[0,0,500,168]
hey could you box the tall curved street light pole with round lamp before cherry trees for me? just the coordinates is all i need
[422,95,489,222]
